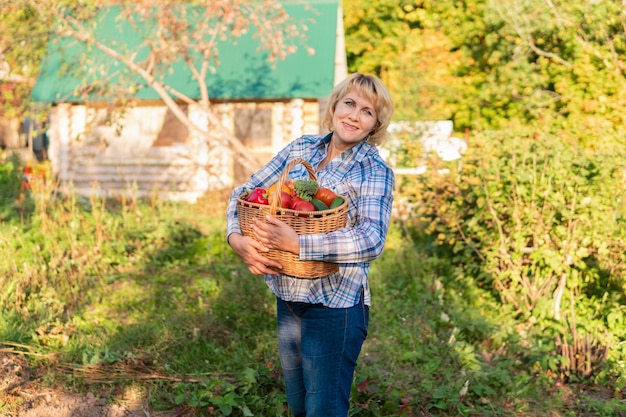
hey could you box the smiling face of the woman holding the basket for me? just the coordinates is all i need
[333,91,378,150]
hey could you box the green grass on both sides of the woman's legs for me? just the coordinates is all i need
[0,160,626,416]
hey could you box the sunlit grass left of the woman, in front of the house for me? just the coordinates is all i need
[0,157,284,416]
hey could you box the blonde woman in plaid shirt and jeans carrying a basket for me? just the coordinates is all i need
[227,73,394,417]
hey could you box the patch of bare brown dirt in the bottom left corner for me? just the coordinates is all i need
[0,349,154,417]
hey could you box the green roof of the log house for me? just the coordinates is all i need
[31,0,339,102]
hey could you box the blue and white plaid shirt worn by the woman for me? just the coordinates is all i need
[227,134,394,308]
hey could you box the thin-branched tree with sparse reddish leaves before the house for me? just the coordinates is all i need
[3,0,304,167]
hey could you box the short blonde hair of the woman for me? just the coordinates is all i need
[322,72,393,146]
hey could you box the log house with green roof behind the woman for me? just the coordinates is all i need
[32,0,347,201]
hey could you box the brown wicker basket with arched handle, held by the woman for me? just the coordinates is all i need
[237,158,348,278]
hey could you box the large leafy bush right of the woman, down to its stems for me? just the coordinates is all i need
[394,128,626,392]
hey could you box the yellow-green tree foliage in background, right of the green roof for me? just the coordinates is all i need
[344,0,626,149]
